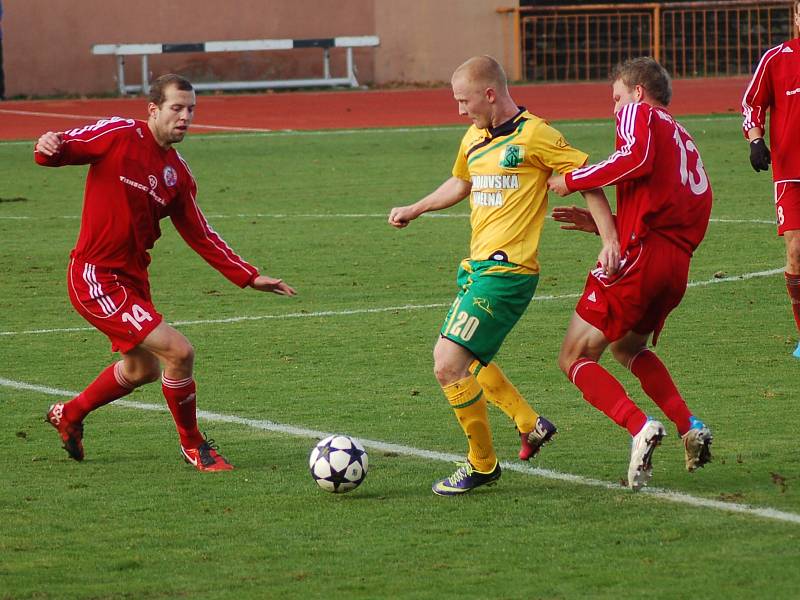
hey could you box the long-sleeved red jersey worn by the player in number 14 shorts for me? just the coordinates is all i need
[34,117,258,287]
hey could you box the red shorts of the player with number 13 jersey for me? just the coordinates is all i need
[575,235,691,345]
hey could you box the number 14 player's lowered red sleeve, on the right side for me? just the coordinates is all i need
[170,162,258,287]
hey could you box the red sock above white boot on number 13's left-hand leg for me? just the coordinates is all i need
[569,358,647,435]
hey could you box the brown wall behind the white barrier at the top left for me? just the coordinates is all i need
[3,0,518,97]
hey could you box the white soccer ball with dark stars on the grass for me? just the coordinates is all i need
[308,435,369,494]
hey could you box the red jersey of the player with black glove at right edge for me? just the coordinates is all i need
[742,39,800,182]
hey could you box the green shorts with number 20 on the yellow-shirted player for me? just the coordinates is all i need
[440,259,539,365]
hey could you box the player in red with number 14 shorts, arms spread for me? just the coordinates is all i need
[34,75,295,471]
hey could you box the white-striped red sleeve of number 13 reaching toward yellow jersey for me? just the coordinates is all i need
[565,102,654,192]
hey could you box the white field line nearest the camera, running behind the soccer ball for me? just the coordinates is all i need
[0,377,800,524]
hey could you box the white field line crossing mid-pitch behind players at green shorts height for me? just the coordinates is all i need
[0,267,784,336]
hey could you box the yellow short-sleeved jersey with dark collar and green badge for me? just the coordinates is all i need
[453,108,588,273]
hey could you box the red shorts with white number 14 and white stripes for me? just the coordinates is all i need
[67,258,164,353]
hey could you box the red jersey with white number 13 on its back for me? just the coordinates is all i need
[566,102,711,255]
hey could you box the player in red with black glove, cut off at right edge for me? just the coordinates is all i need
[742,2,800,358]
